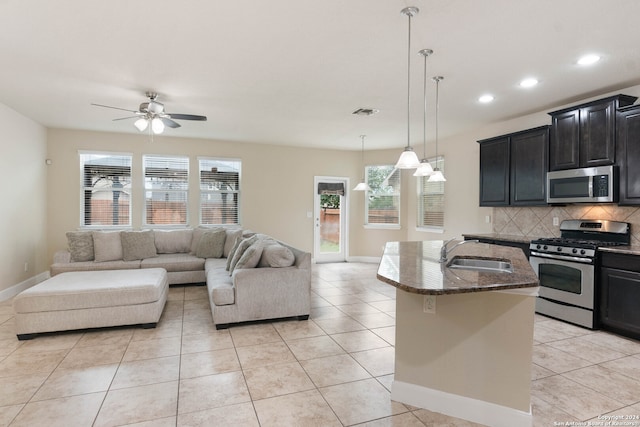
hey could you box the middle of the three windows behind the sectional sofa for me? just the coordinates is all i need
[143,156,189,225]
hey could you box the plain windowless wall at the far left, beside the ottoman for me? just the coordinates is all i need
[0,104,49,292]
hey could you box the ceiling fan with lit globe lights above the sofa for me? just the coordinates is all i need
[91,92,207,134]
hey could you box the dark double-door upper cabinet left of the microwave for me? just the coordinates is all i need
[478,126,549,206]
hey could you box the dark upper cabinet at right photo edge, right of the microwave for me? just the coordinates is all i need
[617,105,640,205]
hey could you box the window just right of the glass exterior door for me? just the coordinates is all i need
[365,165,400,226]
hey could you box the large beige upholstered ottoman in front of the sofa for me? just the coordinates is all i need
[13,268,169,340]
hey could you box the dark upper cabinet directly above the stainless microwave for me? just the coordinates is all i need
[549,95,637,171]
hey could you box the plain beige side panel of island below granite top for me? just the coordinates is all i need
[394,289,535,413]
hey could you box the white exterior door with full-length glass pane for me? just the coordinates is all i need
[314,176,349,263]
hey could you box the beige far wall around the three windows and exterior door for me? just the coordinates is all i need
[47,129,362,258]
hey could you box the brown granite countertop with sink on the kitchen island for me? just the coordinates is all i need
[377,240,538,295]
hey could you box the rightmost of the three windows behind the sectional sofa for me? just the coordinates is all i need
[198,158,241,225]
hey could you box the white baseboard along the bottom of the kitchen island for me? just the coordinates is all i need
[391,381,533,427]
